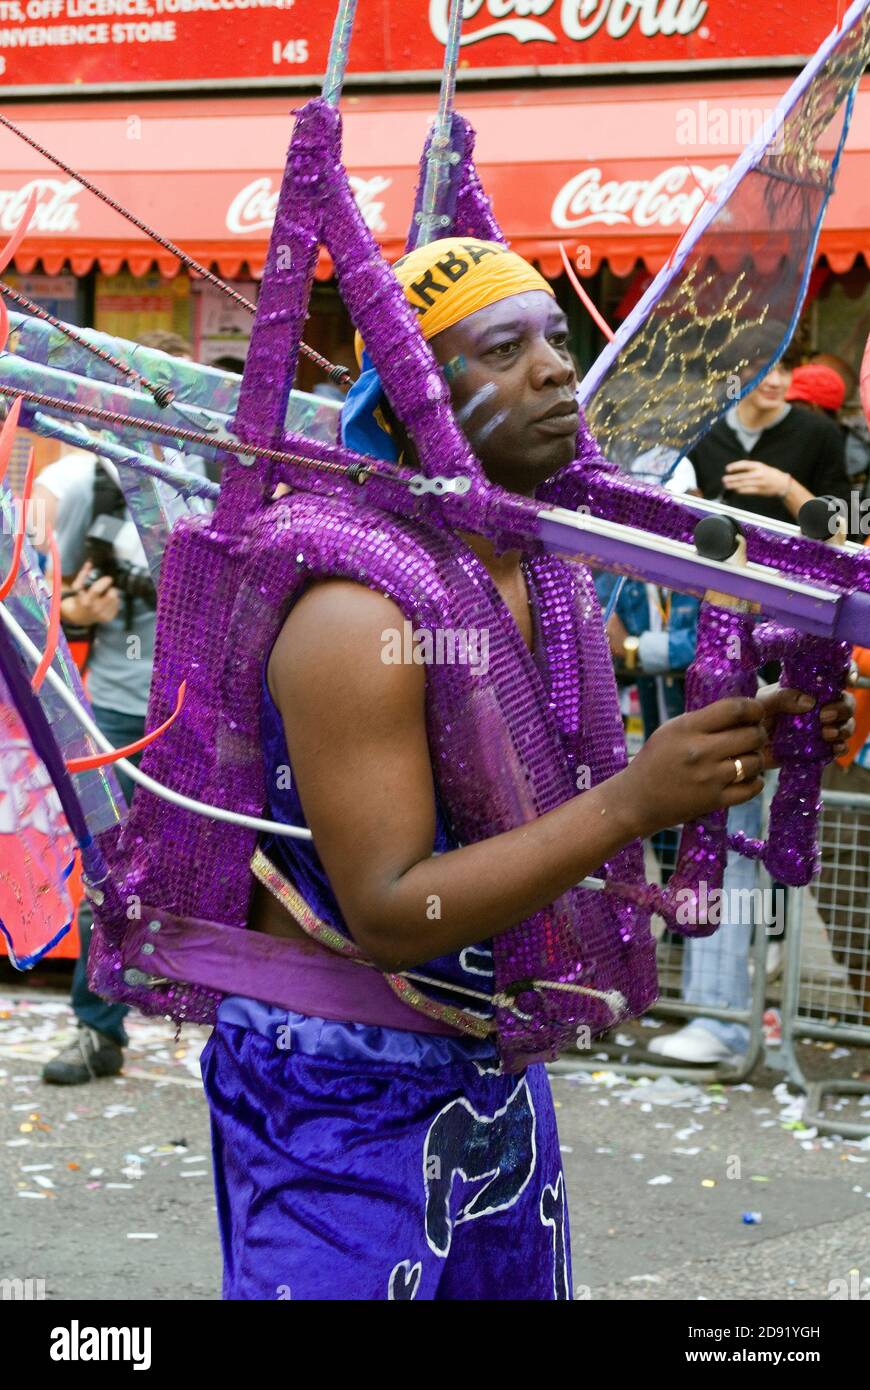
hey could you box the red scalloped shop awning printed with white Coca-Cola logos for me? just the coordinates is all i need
[0,78,870,278]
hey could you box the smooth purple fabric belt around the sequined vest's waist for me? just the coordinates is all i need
[124,908,464,1037]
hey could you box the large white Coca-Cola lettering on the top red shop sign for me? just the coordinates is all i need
[429,0,707,46]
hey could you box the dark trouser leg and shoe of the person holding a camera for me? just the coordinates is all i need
[43,705,145,1086]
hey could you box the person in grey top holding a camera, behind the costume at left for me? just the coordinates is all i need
[33,332,193,1086]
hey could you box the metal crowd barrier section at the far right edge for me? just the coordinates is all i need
[782,791,870,1138]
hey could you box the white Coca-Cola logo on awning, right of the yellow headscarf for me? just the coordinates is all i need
[550,164,728,231]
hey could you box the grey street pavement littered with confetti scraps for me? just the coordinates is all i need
[0,974,870,1302]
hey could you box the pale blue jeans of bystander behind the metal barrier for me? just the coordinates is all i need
[682,796,762,1052]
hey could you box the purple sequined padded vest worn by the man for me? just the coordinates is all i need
[92,483,656,1066]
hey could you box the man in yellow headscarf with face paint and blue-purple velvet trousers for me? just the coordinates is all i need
[203,238,851,1300]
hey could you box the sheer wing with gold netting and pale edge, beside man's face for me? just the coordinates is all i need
[581,0,870,478]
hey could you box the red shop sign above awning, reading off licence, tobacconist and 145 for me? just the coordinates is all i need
[0,0,845,95]
